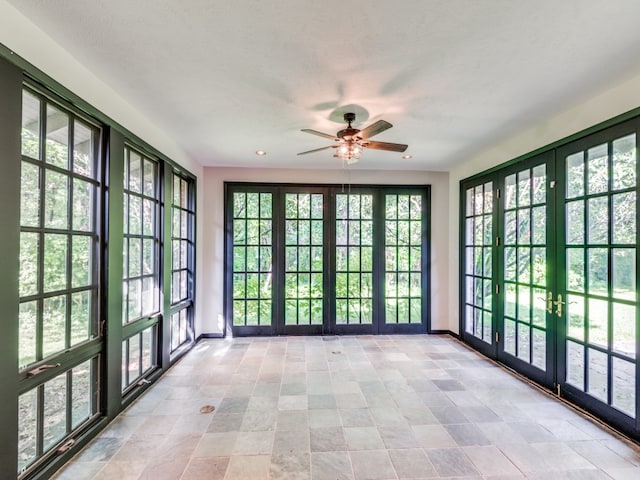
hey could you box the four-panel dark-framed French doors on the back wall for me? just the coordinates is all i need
[225,184,429,335]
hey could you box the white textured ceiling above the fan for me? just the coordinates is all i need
[10,0,640,170]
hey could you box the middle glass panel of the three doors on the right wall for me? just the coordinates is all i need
[499,158,551,382]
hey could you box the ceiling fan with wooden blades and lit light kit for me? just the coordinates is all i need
[298,113,408,163]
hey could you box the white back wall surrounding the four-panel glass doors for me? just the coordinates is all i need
[197,168,455,333]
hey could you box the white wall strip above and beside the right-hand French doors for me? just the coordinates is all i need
[447,75,640,332]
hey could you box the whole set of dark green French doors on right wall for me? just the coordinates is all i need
[461,121,640,438]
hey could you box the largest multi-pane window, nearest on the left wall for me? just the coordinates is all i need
[18,88,102,472]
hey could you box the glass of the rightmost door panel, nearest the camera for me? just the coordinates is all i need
[555,129,638,425]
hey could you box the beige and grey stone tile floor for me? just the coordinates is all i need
[56,335,640,480]
